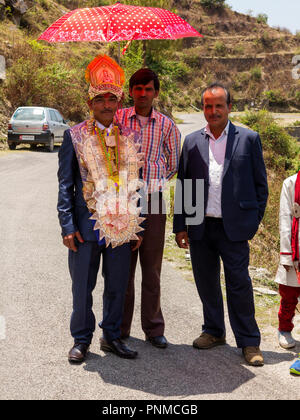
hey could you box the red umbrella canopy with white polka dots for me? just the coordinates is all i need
[38,3,202,42]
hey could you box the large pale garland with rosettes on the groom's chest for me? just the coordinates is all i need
[76,119,144,248]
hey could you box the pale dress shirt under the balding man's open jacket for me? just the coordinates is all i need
[205,121,229,218]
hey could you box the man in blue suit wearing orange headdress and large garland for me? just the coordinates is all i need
[57,56,142,363]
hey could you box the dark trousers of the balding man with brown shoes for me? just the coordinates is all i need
[190,217,260,348]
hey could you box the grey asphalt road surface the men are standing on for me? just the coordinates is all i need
[0,115,300,400]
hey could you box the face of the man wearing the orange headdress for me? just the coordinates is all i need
[88,93,119,126]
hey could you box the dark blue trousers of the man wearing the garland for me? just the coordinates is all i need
[69,241,131,344]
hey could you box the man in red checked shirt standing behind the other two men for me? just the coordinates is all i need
[116,69,181,348]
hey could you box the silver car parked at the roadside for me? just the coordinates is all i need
[7,106,70,152]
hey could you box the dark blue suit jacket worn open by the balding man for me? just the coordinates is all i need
[173,123,268,241]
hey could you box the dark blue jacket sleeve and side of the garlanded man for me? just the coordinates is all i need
[57,130,97,241]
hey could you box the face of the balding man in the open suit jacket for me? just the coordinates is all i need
[203,88,232,130]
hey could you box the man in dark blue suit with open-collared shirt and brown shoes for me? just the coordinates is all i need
[174,83,268,366]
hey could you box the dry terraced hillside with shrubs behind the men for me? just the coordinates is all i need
[0,0,300,135]
